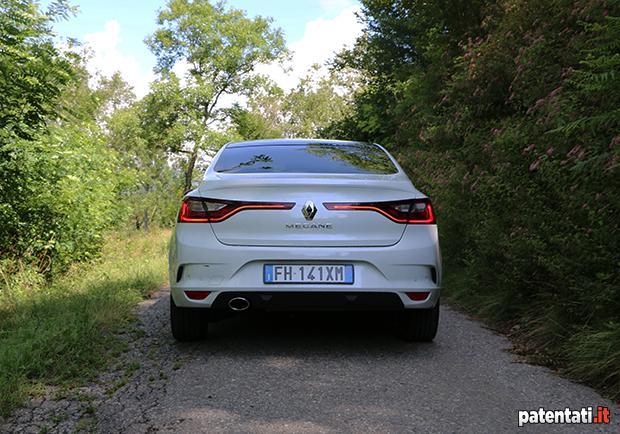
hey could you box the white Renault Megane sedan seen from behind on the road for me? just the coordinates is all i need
[169,139,441,341]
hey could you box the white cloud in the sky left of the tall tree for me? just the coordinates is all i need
[84,20,154,98]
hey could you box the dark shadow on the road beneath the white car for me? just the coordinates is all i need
[172,306,438,357]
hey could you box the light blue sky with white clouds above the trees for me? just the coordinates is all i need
[42,0,361,97]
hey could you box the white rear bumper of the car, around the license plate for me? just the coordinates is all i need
[169,223,442,310]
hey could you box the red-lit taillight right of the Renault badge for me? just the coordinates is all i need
[323,199,435,224]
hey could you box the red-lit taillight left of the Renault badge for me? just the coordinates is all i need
[178,197,295,223]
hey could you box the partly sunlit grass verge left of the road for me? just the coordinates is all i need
[0,230,170,417]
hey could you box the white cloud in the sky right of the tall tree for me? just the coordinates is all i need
[258,4,362,90]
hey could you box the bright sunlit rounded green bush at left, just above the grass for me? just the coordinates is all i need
[0,125,126,271]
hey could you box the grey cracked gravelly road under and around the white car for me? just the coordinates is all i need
[0,290,620,433]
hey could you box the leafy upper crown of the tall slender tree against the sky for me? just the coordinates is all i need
[147,0,284,80]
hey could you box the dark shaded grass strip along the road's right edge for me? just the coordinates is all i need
[442,267,620,402]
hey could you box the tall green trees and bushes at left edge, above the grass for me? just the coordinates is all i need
[0,1,133,272]
